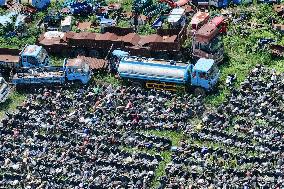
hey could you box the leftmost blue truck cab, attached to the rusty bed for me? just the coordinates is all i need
[20,45,49,68]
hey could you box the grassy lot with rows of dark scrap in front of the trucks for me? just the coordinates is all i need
[0,1,284,188]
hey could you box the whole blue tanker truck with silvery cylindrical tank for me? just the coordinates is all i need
[117,56,220,95]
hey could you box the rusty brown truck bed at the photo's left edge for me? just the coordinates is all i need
[0,48,21,68]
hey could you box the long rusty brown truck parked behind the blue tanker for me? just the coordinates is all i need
[38,24,223,62]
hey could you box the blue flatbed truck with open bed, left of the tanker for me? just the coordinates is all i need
[12,59,91,86]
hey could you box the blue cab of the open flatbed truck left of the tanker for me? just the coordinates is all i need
[63,59,91,84]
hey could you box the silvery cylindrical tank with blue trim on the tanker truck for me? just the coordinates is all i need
[118,57,189,83]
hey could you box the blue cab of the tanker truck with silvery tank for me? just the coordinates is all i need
[190,58,220,91]
